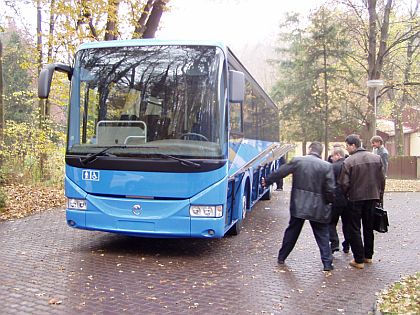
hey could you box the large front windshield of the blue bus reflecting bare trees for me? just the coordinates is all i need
[67,45,227,159]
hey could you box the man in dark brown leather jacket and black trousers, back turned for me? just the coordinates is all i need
[338,135,385,269]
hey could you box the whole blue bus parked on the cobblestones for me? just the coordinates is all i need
[38,39,291,238]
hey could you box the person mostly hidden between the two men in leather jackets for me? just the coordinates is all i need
[329,147,350,253]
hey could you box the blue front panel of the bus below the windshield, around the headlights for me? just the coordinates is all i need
[65,165,227,237]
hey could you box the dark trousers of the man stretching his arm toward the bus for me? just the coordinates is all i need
[278,217,333,267]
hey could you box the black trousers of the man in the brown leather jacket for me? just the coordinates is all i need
[348,200,376,263]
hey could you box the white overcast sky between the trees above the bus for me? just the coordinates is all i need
[157,0,324,46]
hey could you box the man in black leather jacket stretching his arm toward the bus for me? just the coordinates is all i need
[261,142,335,271]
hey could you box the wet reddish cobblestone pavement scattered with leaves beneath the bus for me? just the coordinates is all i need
[0,191,420,314]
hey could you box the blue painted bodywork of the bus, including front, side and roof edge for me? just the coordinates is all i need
[65,39,282,237]
